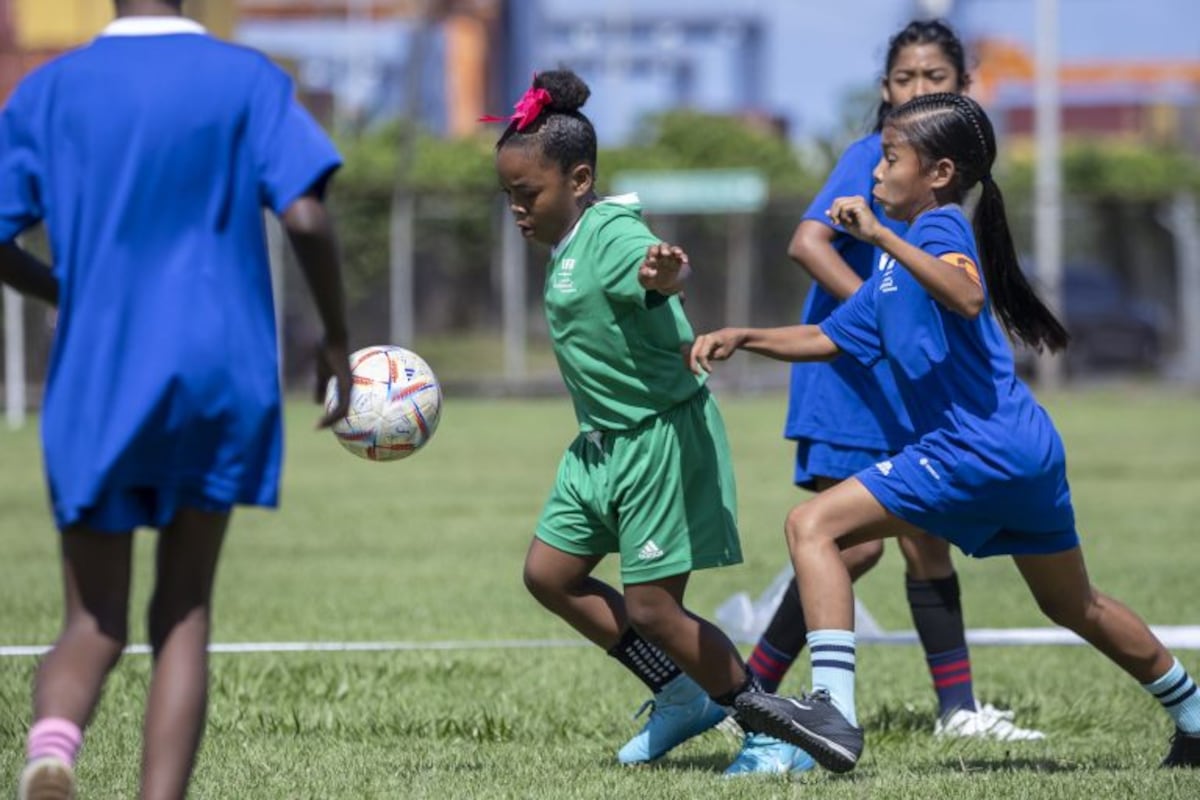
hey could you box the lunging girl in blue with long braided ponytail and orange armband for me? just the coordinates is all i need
[689,94,1200,771]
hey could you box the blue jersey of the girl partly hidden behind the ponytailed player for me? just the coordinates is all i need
[784,133,911,453]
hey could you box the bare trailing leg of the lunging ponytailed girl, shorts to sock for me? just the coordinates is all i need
[1014,547,1174,684]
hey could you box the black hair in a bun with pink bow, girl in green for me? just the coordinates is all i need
[496,70,596,173]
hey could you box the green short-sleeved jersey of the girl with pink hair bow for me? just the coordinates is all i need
[545,196,704,431]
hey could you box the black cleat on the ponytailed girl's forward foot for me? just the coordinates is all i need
[736,688,864,772]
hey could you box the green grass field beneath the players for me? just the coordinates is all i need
[0,389,1200,800]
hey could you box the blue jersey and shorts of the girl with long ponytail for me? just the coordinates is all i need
[821,206,1078,555]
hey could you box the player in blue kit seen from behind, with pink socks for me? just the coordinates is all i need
[0,0,350,799]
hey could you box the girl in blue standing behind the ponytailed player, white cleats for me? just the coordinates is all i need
[728,20,1043,774]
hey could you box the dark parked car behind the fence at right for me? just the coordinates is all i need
[1014,265,1166,375]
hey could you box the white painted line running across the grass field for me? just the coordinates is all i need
[7,625,1200,658]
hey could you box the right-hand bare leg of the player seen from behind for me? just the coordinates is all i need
[142,509,229,800]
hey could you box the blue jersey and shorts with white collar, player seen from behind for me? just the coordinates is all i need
[0,17,340,530]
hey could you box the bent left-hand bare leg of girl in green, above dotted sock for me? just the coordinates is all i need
[524,539,628,650]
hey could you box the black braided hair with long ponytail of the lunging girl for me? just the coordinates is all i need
[884,92,1070,351]
